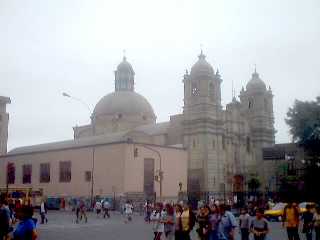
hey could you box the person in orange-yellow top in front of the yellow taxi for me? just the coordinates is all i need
[282,202,300,240]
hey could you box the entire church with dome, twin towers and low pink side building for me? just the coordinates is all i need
[0,51,275,203]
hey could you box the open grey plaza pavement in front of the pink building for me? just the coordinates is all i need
[36,211,288,240]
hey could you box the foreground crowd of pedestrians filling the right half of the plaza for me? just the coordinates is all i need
[145,199,320,240]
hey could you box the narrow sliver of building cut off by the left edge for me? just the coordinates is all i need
[0,96,11,155]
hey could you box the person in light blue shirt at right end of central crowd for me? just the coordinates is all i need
[218,204,237,240]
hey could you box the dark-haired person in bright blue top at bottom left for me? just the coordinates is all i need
[13,206,38,240]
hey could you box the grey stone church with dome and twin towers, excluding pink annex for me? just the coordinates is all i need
[0,51,275,202]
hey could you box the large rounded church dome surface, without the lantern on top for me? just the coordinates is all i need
[93,91,156,119]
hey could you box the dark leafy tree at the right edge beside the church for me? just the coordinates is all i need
[286,96,320,200]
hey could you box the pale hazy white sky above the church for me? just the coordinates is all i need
[0,0,320,149]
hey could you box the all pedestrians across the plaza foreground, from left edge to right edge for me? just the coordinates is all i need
[0,193,320,240]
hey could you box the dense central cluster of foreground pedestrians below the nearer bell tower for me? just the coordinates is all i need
[145,203,237,240]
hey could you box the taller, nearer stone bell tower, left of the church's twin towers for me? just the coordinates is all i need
[183,51,223,199]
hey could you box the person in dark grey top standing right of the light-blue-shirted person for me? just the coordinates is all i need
[250,208,269,240]
